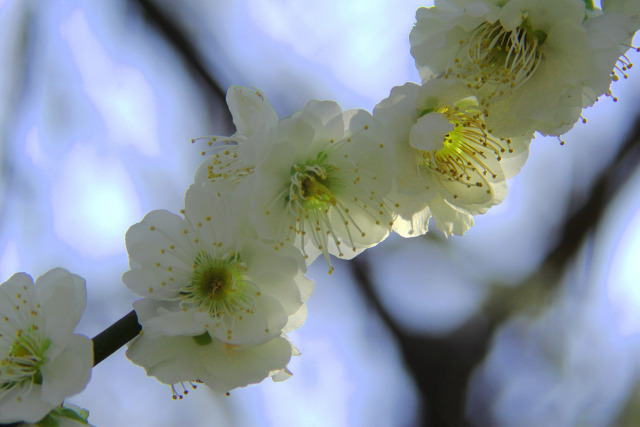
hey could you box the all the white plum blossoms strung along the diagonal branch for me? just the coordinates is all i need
[0,0,640,422]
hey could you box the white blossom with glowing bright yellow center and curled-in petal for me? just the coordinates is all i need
[374,79,531,237]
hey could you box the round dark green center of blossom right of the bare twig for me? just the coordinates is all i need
[180,251,260,317]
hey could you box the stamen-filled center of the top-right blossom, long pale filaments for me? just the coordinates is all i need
[445,20,547,89]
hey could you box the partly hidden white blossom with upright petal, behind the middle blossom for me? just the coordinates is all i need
[192,86,278,189]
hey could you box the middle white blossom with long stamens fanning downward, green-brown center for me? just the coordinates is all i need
[232,101,393,271]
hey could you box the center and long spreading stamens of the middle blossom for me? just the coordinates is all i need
[272,147,391,273]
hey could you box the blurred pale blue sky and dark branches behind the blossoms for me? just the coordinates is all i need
[0,0,640,426]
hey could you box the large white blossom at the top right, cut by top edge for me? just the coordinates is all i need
[410,0,635,137]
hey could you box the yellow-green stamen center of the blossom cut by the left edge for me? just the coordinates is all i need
[0,326,51,397]
